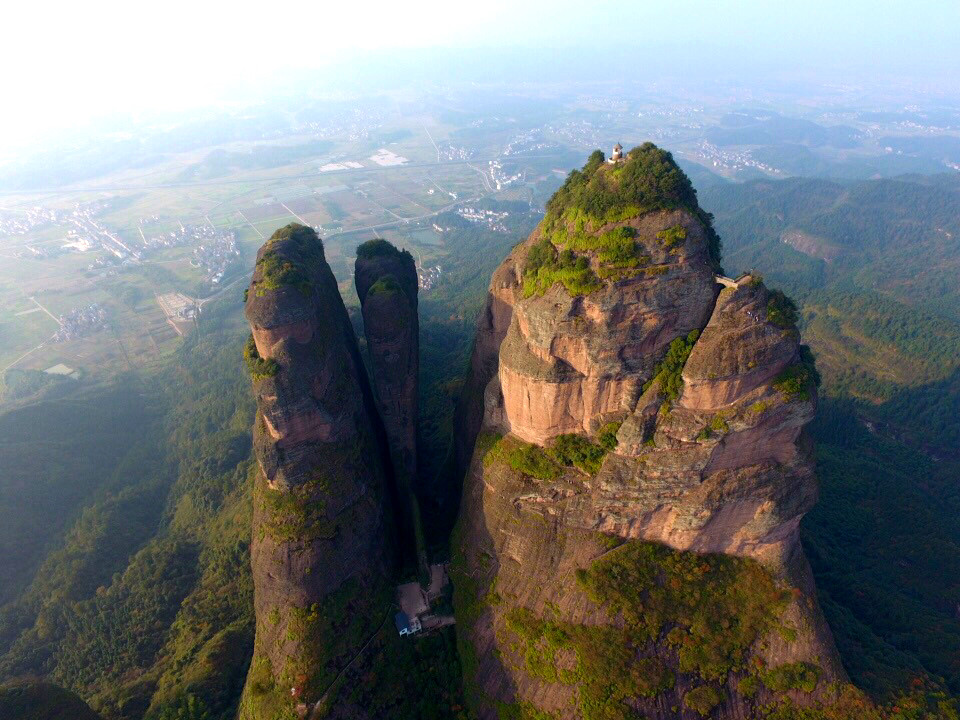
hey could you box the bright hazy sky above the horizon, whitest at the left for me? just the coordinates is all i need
[0,0,960,155]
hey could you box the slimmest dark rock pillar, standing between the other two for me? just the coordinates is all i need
[354,240,426,571]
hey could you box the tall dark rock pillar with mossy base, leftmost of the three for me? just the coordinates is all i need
[240,225,394,720]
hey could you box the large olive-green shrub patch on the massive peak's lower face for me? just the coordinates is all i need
[498,536,792,720]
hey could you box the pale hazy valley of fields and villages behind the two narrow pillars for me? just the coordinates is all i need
[0,123,564,377]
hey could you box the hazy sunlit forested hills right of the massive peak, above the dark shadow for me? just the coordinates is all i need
[702,175,960,447]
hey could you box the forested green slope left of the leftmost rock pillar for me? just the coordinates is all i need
[0,298,252,718]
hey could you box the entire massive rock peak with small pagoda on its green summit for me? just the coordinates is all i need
[453,146,844,719]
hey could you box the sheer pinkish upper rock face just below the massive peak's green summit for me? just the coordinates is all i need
[498,211,716,444]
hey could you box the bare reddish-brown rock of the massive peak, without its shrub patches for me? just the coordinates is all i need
[453,146,845,720]
